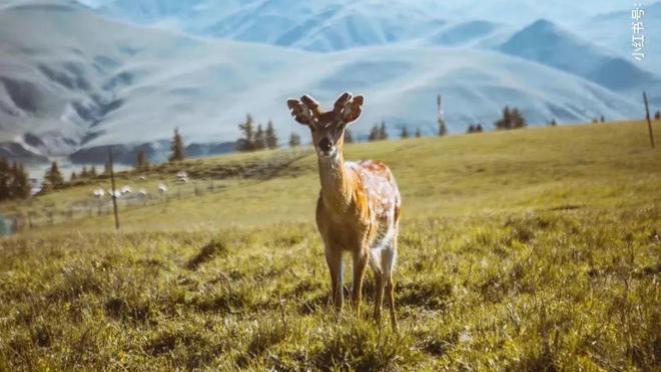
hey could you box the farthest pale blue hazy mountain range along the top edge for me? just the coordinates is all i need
[93,0,627,45]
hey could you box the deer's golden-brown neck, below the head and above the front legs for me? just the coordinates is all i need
[319,152,352,210]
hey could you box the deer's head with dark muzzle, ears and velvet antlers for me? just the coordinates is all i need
[287,93,363,158]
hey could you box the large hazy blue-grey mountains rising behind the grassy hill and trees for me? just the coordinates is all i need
[0,0,661,167]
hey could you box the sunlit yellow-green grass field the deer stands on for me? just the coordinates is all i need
[0,122,661,371]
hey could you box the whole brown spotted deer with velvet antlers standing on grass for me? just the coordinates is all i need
[287,93,401,331]
